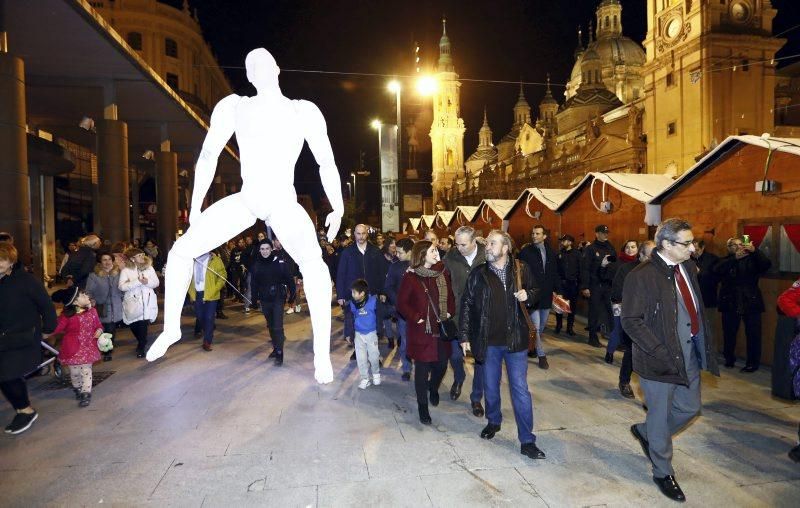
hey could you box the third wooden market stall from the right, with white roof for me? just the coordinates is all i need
[506,187,572,249]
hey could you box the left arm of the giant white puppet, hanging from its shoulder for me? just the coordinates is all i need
[189,95,241,224]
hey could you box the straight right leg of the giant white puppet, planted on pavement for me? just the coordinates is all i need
[269,203,333,383]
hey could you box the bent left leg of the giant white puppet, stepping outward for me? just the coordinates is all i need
[147,194,256,362]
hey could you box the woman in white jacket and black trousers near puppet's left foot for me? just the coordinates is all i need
[119,248,158,358]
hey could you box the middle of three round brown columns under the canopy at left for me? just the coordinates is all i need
[94,119,131,243]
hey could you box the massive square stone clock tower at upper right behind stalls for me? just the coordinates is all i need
[643,0,784,175]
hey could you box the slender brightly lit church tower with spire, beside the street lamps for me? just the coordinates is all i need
[430,19,464,206]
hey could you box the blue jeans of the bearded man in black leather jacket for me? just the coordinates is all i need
[483,346,536,444]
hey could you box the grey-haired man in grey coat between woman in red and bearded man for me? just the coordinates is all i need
[444,226,486,417]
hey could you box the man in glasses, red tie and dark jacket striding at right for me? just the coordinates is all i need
[622,219,719,501]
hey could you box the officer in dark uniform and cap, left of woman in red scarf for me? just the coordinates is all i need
[580,224,617,347]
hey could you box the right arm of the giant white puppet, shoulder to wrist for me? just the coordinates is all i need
[299,101,344,215]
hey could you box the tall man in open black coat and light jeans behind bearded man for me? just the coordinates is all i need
[519,224,561,370]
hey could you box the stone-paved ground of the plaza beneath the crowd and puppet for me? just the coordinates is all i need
[0,306,800,508]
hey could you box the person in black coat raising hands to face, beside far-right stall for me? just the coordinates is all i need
[714,238,772,373]
